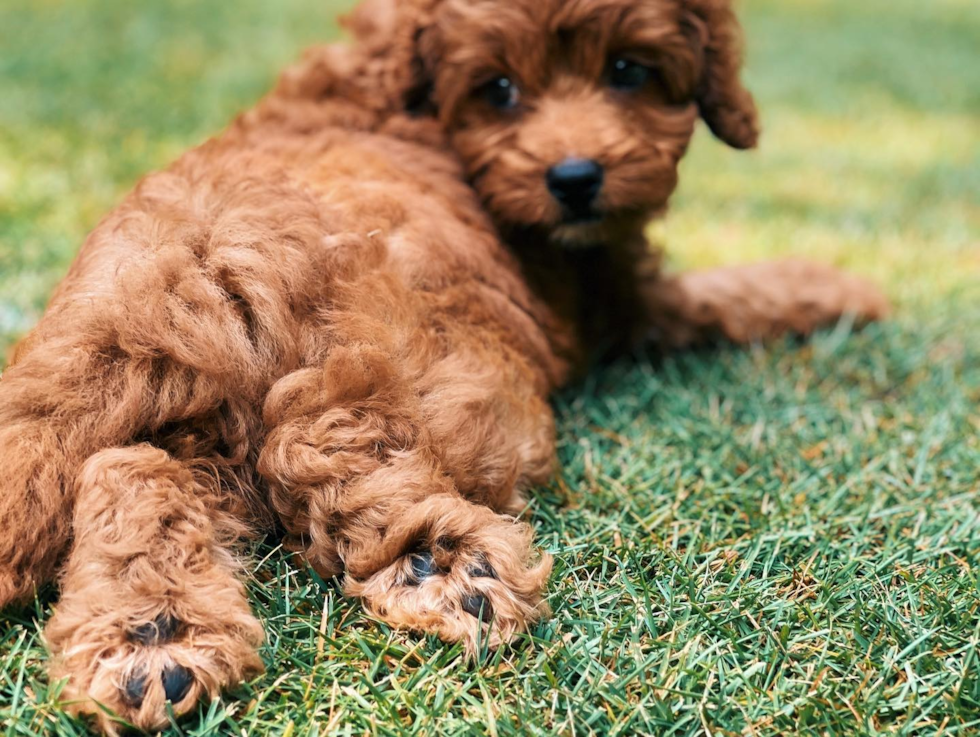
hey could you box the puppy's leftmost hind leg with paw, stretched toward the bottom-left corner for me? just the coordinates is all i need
[44,445,262,733]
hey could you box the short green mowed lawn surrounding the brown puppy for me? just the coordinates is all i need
[0,0,980,736]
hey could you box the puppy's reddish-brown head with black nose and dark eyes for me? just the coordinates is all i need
[349,0,758,243]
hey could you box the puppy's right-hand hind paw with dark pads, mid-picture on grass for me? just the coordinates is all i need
[346,510,552,654]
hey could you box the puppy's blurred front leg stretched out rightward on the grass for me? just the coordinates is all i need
[641,259,889,348]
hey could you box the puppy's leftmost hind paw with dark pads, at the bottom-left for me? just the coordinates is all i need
[45,603,262,734]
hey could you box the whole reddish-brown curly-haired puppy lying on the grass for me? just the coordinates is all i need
[0,0,885,731]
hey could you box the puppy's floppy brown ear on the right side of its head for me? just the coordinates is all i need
[684,0,759,149]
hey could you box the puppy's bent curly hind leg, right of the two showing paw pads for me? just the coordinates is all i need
[259,347,551,650]
